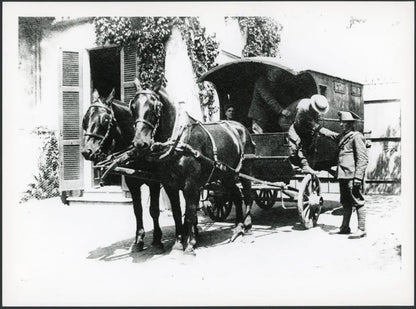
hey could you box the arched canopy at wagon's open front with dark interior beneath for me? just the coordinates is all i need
[198,57,318,123]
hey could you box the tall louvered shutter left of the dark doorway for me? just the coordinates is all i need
[59,51,83,191]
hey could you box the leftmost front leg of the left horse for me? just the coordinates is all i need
[126,177,145,252]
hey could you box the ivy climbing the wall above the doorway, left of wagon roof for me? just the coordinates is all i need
[94,17,218,119]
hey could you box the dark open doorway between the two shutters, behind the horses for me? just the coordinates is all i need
[89,47,121,186]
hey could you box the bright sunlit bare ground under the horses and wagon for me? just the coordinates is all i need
[3,196,414,306]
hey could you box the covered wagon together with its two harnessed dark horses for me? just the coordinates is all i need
[82,58,363,253]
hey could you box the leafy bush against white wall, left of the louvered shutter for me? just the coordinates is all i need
[21,127,59,202]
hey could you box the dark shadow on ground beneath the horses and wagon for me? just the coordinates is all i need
[87,201,342,263]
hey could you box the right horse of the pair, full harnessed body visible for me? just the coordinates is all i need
[130,80,255,254]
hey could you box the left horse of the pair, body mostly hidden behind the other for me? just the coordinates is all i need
[82,89,179,252]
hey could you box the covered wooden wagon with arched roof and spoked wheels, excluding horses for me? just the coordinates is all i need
[199,58,364,228]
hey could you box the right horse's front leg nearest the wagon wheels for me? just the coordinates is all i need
[183,181,199,255]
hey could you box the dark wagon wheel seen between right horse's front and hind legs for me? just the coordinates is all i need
[203,190,233,222]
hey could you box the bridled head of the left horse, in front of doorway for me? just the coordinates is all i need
[81,89,116,162]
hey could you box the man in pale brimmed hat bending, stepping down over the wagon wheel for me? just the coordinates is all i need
[288,94,339,174]
